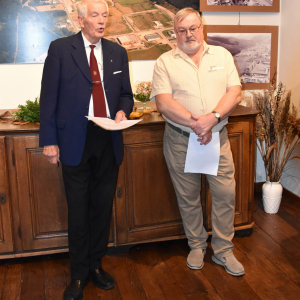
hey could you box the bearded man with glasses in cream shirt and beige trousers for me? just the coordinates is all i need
[151,8,245,276]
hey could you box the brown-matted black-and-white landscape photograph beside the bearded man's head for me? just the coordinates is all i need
[204,25,278,90]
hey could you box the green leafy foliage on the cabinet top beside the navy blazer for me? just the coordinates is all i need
[13,97,40,122]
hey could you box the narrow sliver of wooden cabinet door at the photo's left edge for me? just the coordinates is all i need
[0,136,14,253]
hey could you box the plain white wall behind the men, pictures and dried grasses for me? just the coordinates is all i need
[0,0,300,195]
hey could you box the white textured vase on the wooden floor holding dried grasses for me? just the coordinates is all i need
[262,181,283,214]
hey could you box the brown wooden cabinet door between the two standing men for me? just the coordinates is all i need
[116,140,184,244]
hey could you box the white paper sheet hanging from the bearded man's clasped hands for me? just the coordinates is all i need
[184,132,220,176]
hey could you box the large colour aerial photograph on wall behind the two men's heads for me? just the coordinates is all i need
[0,0,192,64]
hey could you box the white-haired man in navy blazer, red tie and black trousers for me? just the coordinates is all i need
[40,0,133,300]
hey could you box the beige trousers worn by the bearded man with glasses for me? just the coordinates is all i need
[164,124,235,256]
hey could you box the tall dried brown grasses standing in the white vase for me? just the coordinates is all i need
[252,80,300,182]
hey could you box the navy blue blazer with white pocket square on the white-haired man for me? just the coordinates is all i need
[40,32,133,166]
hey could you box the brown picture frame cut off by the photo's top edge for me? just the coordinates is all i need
[200,0,280,12]
